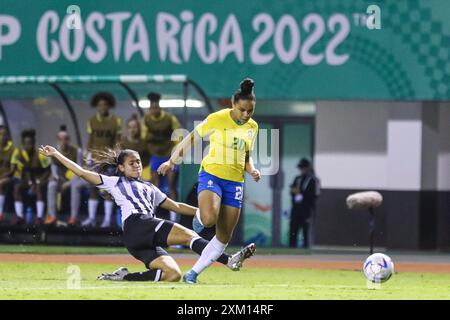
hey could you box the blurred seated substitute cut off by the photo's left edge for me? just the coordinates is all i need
[0,126,18,222]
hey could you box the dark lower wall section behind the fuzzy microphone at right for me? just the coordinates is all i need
[315,189,450,251]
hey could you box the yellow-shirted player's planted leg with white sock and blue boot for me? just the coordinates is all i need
[183,205,241,283]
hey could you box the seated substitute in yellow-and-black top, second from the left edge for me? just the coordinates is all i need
[13,129,50,225]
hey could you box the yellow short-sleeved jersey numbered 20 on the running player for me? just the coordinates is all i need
[195,109,258,182]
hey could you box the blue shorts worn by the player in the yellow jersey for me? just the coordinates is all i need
[197,171,244,208]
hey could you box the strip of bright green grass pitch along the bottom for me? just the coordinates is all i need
[0,262,450,300]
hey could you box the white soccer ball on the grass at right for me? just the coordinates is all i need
[363,253,394,283]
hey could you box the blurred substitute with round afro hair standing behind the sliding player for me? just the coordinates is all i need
[79,92,122,228]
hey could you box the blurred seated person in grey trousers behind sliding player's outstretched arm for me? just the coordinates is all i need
[45,125,83,225]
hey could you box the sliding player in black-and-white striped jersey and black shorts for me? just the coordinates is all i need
[39,146,255,281]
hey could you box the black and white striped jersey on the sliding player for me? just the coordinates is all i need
[97,174,167,223]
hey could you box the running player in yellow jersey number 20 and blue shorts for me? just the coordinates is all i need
[158,79,261,283]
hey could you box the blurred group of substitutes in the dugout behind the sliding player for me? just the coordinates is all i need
[0,92,181,228]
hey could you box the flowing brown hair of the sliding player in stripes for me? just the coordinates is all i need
[89,145,139,176]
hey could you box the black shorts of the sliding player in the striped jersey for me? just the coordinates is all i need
[123,214,174,269]
